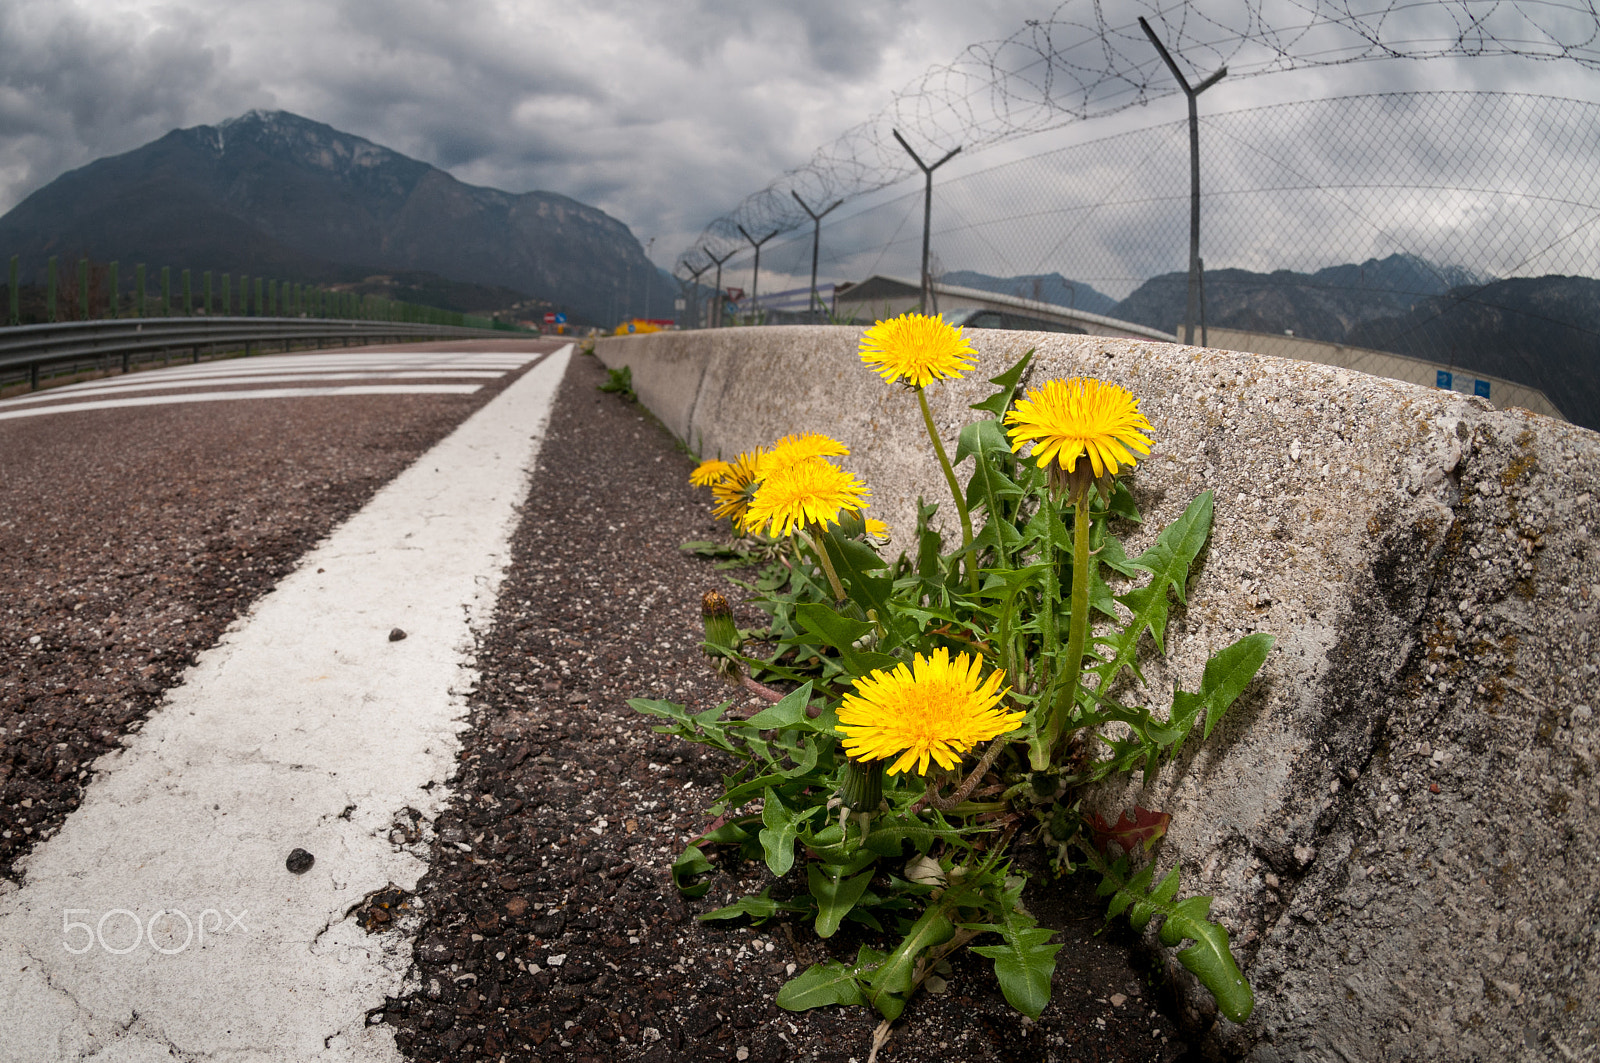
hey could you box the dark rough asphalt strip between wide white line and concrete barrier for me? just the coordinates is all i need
[368,357,1190,1063]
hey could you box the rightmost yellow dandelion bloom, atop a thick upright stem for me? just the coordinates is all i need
[1005,376,1154,482]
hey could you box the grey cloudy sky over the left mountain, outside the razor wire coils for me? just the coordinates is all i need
[0,0,1600,281]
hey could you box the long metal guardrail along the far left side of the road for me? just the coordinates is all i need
[0,317,506,391]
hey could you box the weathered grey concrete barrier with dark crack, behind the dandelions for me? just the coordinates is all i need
[598,328,1600,1063]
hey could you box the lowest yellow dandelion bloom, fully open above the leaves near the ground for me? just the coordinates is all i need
[838,647,1024,775]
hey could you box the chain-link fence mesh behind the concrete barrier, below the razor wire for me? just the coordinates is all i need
[697,93,1600,426]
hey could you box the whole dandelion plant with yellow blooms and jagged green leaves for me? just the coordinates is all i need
[630,314,1272,1044]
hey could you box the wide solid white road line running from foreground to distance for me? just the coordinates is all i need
[0,346,571,1063]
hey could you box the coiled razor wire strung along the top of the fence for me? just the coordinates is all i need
[674,0,1600,272]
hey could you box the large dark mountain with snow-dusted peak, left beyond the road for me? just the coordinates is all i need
[0,110,674,322]
